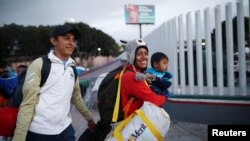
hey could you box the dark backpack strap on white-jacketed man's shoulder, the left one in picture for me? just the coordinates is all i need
[40,55,51,87]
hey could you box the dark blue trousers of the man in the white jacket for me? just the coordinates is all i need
[26,124,76,141]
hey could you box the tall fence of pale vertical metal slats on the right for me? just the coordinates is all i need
[144,0,250,96]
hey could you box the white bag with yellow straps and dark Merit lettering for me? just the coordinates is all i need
[107,102,170,141]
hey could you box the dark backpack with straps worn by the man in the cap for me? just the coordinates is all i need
[10,55,77,107]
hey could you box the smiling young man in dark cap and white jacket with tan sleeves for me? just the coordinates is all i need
[13,25,95,141]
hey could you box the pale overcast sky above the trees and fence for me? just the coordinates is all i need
[0,0,248,42]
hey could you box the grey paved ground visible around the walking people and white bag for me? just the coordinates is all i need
[0,107,207,141]
